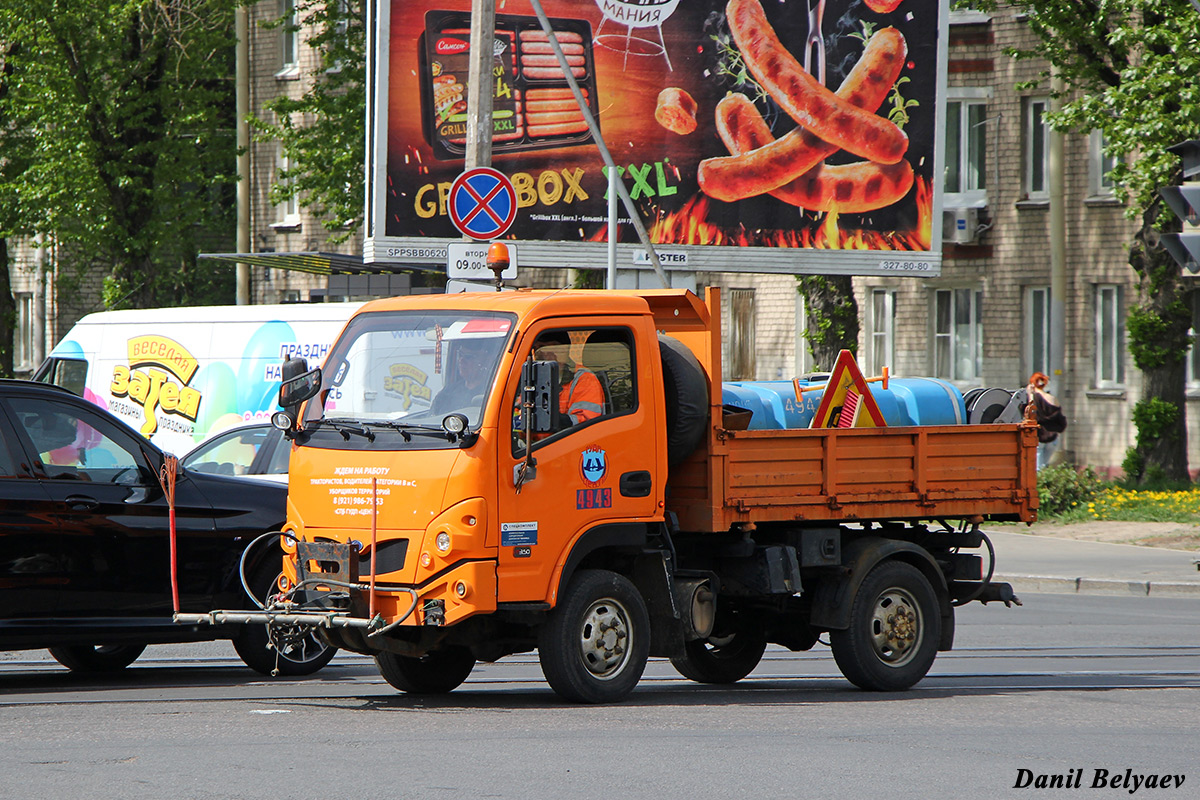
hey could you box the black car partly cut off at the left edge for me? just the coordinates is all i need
[0,380,335,675]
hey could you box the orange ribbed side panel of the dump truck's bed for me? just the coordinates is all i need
[667,423,1038,531]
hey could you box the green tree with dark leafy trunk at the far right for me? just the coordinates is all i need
[972,0,1200,480]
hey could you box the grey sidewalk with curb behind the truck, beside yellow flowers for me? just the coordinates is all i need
[984,523,1200,597]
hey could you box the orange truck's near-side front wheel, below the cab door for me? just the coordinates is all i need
[538,570,650,703]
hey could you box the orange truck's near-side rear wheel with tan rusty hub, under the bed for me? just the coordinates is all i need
[829,561,942,692]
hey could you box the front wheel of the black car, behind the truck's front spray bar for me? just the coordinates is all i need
[233,567,337,678]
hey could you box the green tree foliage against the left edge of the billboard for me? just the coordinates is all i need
[251,0,366,242]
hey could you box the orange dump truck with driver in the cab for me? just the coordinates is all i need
[177,289,1038,703]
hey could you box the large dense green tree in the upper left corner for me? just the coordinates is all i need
[0,0,235,308]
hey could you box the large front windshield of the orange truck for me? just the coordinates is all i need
[307,311,516,431]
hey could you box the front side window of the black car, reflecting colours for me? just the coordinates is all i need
[10,397,143,482]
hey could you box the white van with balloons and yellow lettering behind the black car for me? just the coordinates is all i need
[34,302,362,455]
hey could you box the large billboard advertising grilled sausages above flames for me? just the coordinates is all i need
[365,0,948,276]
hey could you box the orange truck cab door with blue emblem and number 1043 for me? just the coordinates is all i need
[498,317,662,602]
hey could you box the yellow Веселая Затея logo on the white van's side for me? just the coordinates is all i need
[110,335,200,437]
